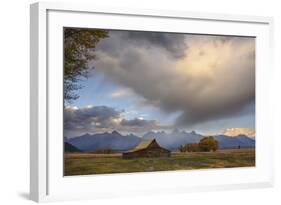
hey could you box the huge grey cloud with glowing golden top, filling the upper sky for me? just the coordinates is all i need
[90,31,255,127]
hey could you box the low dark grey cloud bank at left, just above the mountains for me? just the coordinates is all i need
[64,106,164,137]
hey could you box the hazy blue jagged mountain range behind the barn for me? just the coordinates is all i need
[64,129,255,151]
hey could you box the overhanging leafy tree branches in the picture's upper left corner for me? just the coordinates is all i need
[63,28,108,102]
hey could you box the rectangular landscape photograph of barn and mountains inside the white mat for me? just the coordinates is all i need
[62,27,256,176]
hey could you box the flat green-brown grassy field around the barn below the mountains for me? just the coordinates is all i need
[64,149,255,176]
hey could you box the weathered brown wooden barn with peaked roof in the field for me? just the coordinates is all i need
[123,139,171,159]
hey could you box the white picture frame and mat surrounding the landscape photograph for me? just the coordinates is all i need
[30,2,274,202]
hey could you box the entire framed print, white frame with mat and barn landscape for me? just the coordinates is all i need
[30,3,273,201]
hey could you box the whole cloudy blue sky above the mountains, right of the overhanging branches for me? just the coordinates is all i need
[64,31,255,136]
